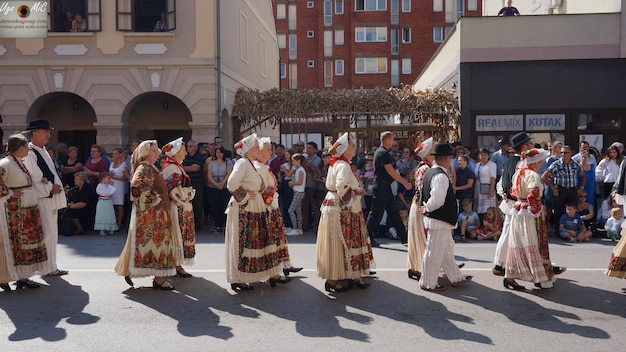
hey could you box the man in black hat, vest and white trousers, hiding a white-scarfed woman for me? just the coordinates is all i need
[419,143,472,291]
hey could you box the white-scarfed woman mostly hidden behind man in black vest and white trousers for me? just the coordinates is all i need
[407,137,435,281]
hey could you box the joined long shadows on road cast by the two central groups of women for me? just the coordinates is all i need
[222,278,492,345]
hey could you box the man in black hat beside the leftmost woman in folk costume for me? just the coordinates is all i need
[24,120,67,275]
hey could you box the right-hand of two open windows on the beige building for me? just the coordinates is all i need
[117,0,176,32]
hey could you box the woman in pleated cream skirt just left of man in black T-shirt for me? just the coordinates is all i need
[317,132,374,292]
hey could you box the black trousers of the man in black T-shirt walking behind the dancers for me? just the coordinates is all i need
[367,183,407,243]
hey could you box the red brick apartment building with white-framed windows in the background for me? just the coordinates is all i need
[272,0,482,89]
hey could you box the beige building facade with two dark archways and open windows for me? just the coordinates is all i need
[0,0,279,157]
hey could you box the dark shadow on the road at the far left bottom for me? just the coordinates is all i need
[0,277,100,341]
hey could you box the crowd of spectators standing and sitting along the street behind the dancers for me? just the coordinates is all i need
[44,136,624,241]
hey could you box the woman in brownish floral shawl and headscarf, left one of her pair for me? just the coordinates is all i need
[115,140,183,290]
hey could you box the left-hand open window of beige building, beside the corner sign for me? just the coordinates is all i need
[48,0,102,32]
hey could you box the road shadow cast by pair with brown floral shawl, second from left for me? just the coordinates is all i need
[123,276,259,340]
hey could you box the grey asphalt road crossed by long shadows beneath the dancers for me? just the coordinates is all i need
[0,232,626,352]
